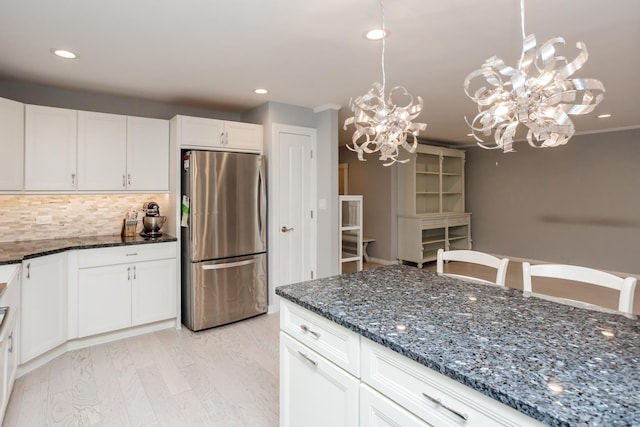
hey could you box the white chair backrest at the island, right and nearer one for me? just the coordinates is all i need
[522,262,637,315]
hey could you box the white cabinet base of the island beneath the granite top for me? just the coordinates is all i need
[280,300,543,427]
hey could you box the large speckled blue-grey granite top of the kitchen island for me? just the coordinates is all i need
[276,265,640,426]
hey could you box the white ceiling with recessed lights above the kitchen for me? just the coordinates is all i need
[0,0,640,144]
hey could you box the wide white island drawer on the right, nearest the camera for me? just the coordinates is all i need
[362,339,543,427]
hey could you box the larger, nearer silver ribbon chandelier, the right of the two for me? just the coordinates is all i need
[464,0,605,153]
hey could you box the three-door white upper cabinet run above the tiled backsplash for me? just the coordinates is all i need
[22,106,169,192]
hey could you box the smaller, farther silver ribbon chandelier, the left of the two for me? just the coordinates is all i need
[344,0,427,166]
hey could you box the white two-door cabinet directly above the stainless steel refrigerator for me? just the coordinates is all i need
[172,116,263,153]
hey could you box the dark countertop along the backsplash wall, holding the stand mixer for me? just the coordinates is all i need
[0,234,178,265]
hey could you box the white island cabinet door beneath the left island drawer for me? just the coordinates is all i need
[280,332,359,427]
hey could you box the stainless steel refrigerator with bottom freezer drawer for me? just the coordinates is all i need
[181,150,267,331]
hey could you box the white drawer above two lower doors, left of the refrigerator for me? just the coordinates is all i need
[78,242,176,268]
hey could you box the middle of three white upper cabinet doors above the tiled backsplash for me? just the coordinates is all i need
[78,111,127,191]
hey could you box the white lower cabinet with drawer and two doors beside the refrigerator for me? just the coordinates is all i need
[78,243,178,337]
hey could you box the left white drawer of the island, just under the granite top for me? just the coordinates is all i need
[280,299,360,377]
